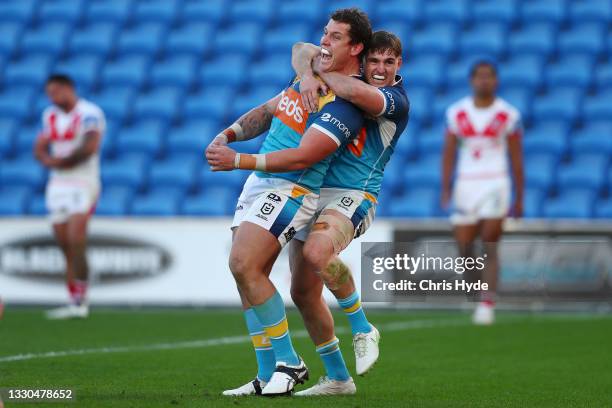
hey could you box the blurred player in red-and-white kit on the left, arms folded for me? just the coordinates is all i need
[34,75,105,319]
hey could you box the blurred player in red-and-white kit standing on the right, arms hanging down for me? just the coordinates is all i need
[441,60,523,324]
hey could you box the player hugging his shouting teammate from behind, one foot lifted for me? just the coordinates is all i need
[211,27,409,396]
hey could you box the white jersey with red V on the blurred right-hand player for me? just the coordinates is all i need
[446,96,522,179]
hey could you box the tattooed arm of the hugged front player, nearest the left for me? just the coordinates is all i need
[207,95,280,147]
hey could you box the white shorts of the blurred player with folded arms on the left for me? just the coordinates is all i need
[45,178,100,224]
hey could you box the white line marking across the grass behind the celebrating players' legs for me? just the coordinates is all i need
[0,318,462,363]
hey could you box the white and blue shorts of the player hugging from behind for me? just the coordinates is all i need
[295,188,377,241]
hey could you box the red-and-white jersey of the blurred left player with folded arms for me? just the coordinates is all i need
[42,99,106,183]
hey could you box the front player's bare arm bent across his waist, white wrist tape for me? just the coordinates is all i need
[206,128,338,173]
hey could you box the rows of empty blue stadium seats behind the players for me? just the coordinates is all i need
[0,0,612,218]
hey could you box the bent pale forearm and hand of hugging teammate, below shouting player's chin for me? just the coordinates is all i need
[291,42,327,113]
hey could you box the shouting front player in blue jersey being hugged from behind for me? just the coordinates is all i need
[206,9,372,395]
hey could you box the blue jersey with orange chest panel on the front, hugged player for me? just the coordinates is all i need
[255,79,364,193]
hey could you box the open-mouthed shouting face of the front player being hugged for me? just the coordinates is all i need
[321,19,363,72]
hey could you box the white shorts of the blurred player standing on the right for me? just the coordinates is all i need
[451,177,511,225]
